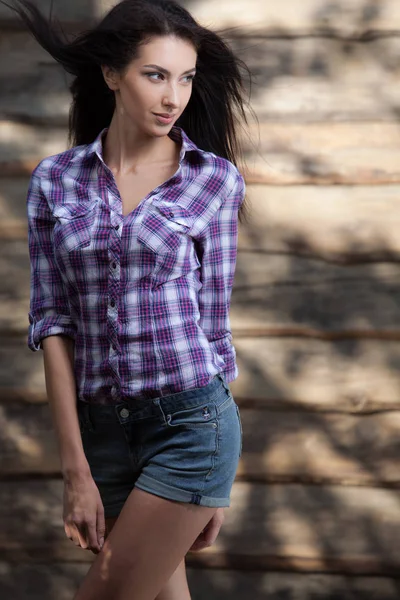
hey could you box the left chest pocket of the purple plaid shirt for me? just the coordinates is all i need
[53,200,96,253]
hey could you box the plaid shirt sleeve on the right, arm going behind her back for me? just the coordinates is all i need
[197,172,245,382]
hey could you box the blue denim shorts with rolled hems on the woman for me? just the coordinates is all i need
[77,375,242,517]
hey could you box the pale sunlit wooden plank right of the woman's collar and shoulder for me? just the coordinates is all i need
[241,123,400,185]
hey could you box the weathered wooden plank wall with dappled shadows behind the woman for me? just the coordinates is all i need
[0,0,400,600]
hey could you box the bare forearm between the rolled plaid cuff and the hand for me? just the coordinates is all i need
[42,335,90,480]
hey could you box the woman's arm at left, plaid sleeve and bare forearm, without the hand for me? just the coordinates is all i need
[27,168,89,477]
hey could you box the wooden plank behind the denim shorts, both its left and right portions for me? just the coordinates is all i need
[0,402,400,488]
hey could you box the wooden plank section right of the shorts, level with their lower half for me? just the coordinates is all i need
[237,409,400,488]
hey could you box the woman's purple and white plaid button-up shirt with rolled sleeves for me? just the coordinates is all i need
[27,126,245,404]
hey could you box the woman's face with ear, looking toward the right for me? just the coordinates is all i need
[103,36,197,136]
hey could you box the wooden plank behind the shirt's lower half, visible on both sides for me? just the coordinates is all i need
[6,240,400,339]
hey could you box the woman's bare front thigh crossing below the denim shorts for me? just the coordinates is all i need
[74,488,217,600]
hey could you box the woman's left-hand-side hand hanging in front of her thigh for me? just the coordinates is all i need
[63,475,105,554]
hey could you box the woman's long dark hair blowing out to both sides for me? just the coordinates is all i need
[0,0,251,221]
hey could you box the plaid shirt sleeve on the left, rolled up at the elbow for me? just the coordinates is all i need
[26,165,76,352]
